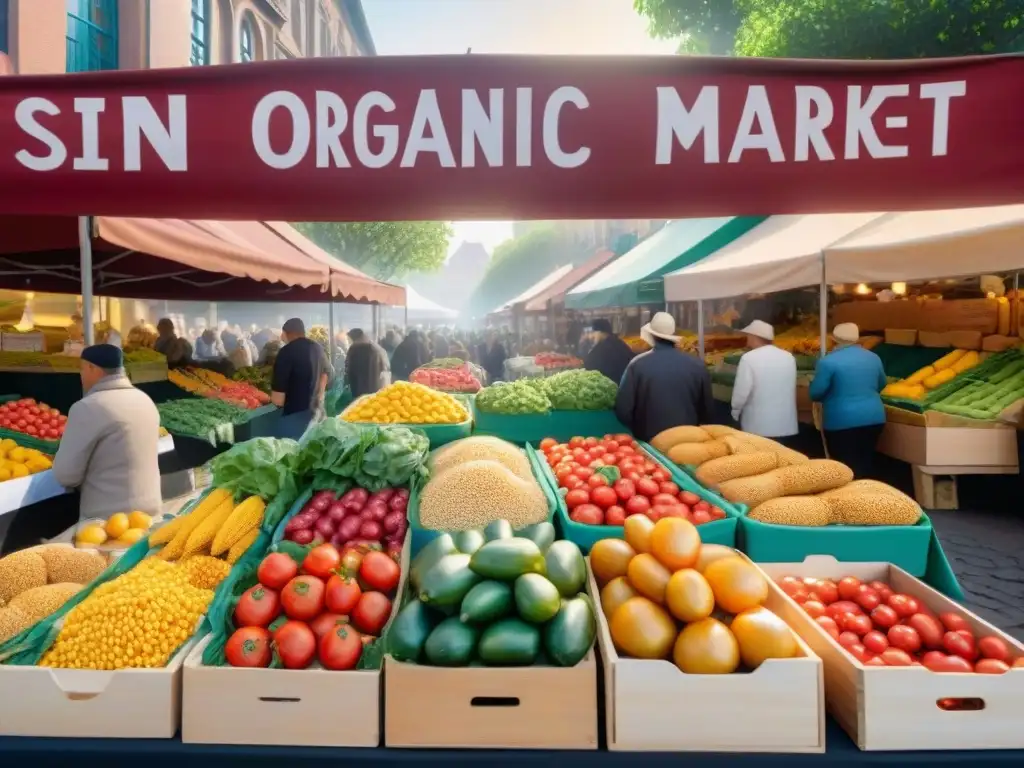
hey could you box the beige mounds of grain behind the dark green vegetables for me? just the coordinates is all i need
[419,436,551,530]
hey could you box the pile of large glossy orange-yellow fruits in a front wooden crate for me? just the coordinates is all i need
[590,515,801,675]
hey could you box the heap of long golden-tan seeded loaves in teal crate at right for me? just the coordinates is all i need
[651,425,922,526]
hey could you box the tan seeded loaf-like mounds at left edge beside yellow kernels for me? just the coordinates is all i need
[0,544,106,642]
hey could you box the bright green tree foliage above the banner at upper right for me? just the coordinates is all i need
[634,0,1024,58]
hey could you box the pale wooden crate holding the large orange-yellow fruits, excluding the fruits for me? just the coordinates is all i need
[587,558,825,753]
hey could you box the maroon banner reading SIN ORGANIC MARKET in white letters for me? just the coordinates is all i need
[0,55,1024,221]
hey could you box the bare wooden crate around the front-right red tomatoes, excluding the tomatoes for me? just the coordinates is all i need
[758,555,1024,751]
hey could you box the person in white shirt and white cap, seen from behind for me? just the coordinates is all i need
[732,321,800,439]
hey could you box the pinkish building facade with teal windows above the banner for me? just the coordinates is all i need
[0,0,376,75]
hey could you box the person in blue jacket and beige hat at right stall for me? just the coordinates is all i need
[810,323,886,478]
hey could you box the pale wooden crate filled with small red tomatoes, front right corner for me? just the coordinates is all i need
[759,555,1024,751]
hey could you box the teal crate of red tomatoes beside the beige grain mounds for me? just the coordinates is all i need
[529,433,737,552]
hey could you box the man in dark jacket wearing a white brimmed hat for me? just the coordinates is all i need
[615,312,715,440]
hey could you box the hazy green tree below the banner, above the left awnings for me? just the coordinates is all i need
[295,221,453,280]
